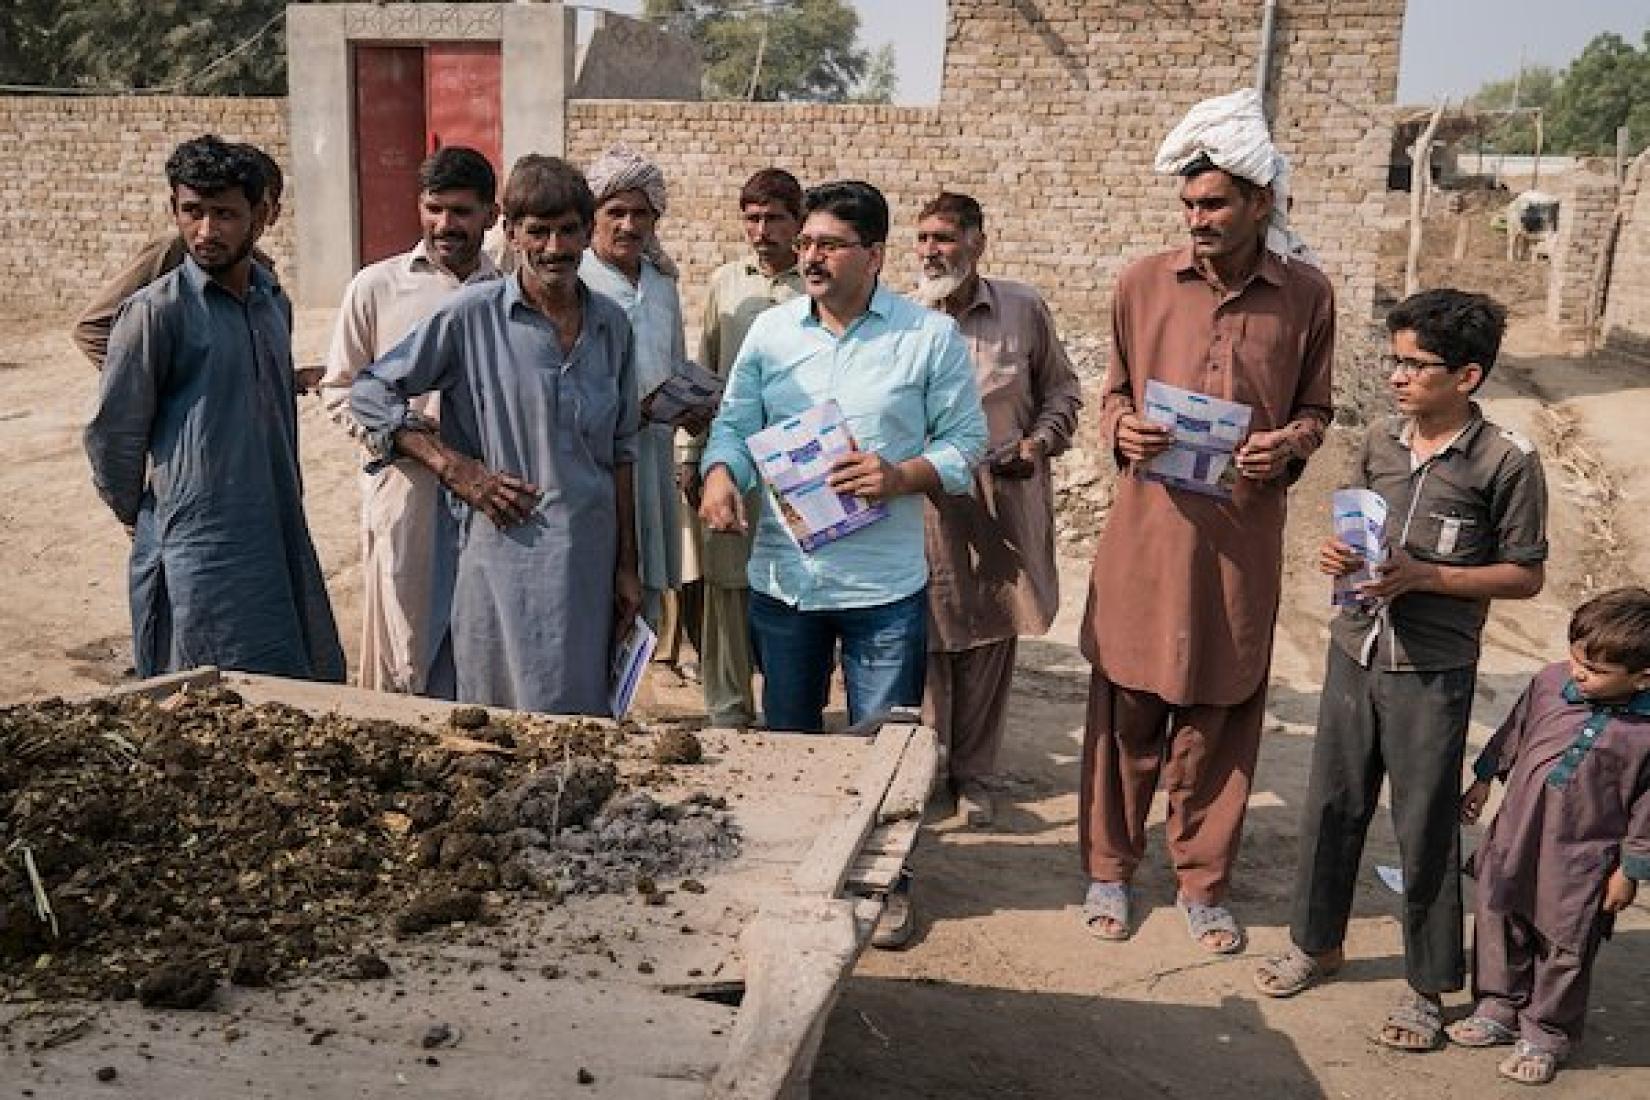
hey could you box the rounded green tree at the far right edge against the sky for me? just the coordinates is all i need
[1553,31,1650,153]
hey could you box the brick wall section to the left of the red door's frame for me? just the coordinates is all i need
[0,96,292,315]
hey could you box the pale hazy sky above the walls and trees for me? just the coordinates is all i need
[582,0,1650,104]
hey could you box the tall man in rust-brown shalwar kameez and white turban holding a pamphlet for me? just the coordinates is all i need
[1079,89,1335,953]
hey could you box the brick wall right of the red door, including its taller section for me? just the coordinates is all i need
[568,0,1404,331]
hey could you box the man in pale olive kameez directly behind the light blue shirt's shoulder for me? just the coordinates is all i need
[677,168,802,729]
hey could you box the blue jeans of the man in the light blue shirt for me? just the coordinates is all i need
[751,589,927,732]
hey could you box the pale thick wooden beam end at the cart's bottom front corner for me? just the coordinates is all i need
[705,897,861,1100]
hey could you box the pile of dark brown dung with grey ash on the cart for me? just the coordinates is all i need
[0,688,738,1004]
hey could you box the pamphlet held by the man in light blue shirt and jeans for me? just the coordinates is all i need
[746,401,888,554]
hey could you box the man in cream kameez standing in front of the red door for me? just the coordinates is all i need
[320,145,498,696]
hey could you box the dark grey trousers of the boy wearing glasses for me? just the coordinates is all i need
[1289,645,1477,993]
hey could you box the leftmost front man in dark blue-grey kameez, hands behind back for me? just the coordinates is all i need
[86,135,343,681]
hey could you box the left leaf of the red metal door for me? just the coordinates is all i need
[353,46,424,267]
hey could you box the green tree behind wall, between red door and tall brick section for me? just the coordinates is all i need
[644,0,871,102]
